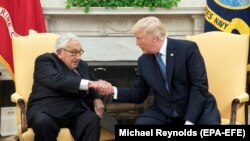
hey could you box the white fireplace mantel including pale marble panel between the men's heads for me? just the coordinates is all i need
[43,7,205,61]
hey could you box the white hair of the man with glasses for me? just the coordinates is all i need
[55,33,80,50]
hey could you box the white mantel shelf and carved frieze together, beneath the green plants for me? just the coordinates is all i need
[43,7,205,36]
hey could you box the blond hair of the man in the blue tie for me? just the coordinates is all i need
[131,16,166,40]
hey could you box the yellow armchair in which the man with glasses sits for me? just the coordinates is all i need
[11,33,114,141]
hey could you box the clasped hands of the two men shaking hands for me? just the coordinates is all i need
[88,80,114,96]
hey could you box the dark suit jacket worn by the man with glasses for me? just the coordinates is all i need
[27,53,100,120]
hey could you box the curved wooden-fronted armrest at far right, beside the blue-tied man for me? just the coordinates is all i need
[230,92,249,124]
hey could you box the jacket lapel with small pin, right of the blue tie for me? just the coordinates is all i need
[166,38,176,91]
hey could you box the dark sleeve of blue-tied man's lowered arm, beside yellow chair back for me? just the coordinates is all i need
[185,42,208,123]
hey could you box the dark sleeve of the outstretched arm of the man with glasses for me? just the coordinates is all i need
[34,54,81,94]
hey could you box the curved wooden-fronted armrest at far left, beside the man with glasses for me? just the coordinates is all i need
[11,92,28,133]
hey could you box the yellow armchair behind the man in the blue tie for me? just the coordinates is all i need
[186,31,249,124]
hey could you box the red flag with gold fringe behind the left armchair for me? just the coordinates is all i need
[0,0,46,79]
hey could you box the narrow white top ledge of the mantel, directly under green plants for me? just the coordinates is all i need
[43,7,205,15]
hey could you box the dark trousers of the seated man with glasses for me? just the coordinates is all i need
[30,104,100,141]
